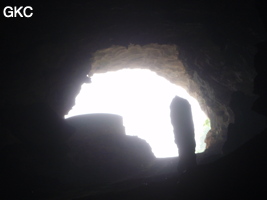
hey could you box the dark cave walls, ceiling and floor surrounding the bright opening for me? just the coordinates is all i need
[0,0,267,200]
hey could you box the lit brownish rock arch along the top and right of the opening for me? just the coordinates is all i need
[65,44,233,158]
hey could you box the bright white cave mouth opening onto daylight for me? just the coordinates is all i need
[65,69,210,158]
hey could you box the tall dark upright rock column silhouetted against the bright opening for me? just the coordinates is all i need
[170,96,196,172]
